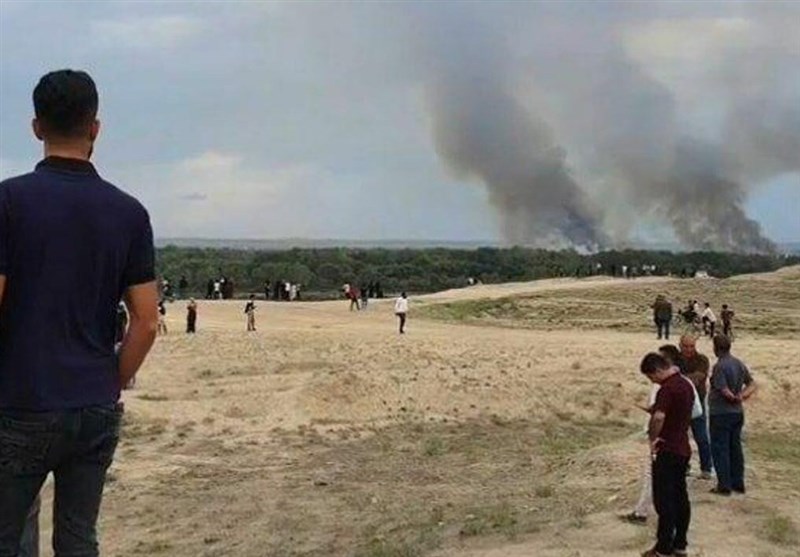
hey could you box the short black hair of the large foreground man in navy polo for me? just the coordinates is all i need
[33,70,98,138]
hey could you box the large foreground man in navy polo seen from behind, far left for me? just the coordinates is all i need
[0,70,158,557]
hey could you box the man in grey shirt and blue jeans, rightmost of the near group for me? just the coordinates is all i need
[708,335,757,495]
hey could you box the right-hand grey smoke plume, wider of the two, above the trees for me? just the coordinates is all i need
[510,3,800,252]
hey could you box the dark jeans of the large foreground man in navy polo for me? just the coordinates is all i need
[0,405,122,557]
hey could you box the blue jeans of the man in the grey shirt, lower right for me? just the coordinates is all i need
[711,413,744,491]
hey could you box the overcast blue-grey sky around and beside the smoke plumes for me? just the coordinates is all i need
[0,0,800,241]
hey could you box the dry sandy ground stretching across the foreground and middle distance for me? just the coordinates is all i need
[37,272,800,557]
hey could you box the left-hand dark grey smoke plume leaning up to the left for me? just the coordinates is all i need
[412,7,607,249]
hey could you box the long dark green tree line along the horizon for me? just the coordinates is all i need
[157,246,800,299]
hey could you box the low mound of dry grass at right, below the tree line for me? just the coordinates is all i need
[419,267,800,335]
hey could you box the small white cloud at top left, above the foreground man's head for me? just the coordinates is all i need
[91,15,204,50]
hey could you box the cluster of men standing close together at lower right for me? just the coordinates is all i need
[623,335,756,557]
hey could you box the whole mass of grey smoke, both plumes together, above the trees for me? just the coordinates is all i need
[415,4,800,252]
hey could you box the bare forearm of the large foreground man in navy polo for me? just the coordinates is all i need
[119,281,158,387]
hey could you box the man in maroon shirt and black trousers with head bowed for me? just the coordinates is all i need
[640,353,694,557]
